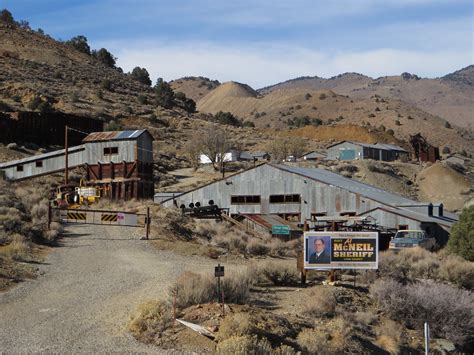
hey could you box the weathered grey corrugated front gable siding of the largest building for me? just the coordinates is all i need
[164,165,379,222]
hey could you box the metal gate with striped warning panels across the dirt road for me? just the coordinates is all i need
[48,207,151,239]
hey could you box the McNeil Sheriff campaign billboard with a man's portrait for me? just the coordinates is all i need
[304,232,378,269]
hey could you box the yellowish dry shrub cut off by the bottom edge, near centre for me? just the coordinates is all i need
[217,335,273,355]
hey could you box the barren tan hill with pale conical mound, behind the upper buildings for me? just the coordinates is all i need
[198,83,473,151]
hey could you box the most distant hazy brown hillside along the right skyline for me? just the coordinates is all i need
[258,65,474,128]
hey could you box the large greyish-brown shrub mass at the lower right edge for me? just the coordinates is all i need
[370,279,474,346]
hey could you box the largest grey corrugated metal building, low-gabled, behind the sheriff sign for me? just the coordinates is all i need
[163,164,454,245]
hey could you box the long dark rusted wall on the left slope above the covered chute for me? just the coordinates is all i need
[0,112,104,146]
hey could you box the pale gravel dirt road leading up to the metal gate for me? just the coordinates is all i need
[0,225,218,353]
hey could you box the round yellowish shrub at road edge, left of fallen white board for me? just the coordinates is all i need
[128,301,173,342]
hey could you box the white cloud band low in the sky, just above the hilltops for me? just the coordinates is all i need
[107,42,472,88]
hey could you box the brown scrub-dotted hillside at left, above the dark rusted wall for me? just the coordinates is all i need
[0,23,160,118]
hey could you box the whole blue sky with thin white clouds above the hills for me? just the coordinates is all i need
[0,0,474,88]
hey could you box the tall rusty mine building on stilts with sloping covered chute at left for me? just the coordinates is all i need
[0,130,154,199]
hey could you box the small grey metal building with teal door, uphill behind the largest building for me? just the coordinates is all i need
[327,141,409,161]
